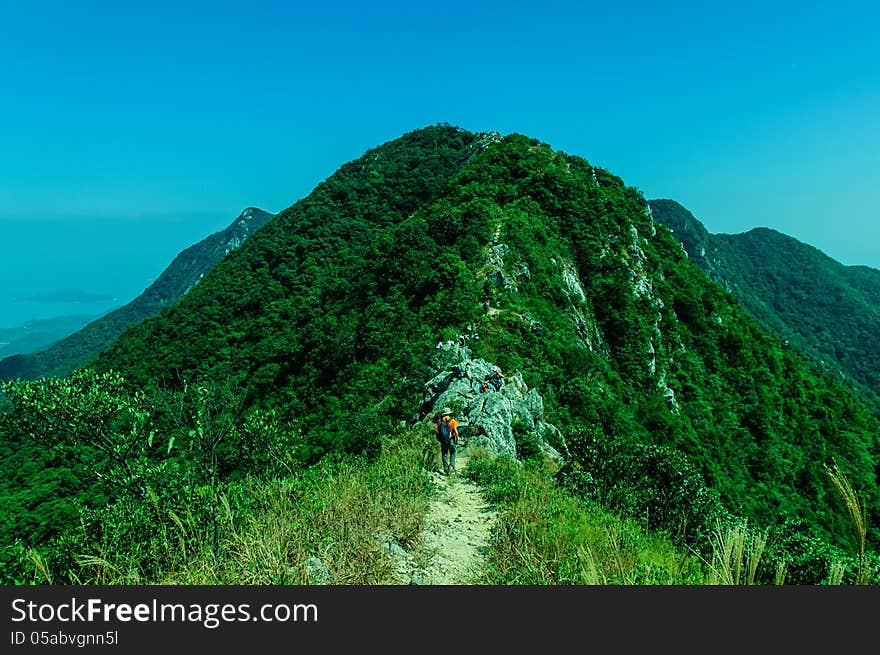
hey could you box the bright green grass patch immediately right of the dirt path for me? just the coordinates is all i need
[465,457,704,585]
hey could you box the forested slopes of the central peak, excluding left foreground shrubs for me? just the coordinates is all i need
[94,126,880,564]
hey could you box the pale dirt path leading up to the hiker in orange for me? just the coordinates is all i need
[389,450,496,585]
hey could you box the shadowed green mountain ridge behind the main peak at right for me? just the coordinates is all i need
[649,200,880,399]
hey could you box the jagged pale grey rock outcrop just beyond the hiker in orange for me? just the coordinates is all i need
[422,344,567,463]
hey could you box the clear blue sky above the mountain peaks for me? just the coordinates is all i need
[0,0,880,272]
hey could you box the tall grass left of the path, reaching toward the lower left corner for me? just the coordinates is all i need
[43,433,436,585]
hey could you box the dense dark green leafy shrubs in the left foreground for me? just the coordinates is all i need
[0,370,299,582]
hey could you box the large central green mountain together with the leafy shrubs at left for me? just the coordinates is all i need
[0,125,880,582]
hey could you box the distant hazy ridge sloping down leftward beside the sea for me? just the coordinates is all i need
[0,207,273,380]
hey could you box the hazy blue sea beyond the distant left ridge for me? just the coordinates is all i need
[0,212,232,328]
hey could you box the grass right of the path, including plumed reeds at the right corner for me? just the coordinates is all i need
[466,457,880,586]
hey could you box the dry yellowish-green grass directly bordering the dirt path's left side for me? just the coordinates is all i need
[162,435,434,585]
